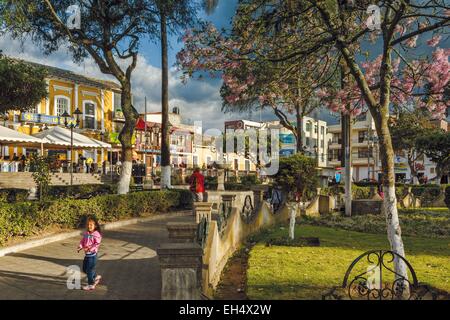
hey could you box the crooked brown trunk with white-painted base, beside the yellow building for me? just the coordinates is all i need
[117,79,137,194]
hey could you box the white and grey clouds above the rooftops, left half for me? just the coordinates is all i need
[0,36,234,129]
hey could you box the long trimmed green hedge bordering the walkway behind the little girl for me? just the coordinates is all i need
[0,190,187,244]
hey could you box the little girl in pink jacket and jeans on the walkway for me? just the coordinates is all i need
[77,216,102,290]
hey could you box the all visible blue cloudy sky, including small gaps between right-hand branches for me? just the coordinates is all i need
[0,0,449,129]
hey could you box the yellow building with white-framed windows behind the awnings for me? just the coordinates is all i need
[1,59,124,165]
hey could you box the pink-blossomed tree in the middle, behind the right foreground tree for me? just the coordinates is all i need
[177,2,339,152]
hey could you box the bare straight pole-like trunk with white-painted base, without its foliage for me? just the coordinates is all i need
[161,10,171,189]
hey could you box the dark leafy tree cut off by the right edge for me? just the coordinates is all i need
[417,130,450,183]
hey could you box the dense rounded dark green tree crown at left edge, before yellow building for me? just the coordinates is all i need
[0,52,47,112]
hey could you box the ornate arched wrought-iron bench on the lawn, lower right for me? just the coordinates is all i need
[322,250,437,300]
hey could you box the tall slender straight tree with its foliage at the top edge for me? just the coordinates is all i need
[156,0,197,188]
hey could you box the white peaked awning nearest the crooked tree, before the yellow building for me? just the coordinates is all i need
[34,126,111,149]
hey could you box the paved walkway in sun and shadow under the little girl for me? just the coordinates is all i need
[0,212,192,299]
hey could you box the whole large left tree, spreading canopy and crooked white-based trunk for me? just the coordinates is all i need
[0,0,158,194]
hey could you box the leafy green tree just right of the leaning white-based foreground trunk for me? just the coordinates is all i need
[389,109,433,182]
